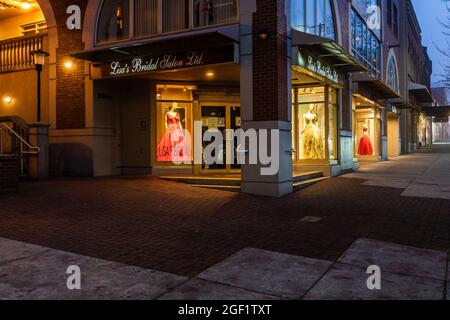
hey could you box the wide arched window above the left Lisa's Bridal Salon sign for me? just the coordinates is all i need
[97,0,239,43]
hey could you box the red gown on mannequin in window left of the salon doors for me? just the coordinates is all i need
[157,113,191,162]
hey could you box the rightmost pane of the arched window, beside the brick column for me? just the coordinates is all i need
[193,0,238,28]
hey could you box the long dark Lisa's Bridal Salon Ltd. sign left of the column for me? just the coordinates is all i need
[91,44,236,79]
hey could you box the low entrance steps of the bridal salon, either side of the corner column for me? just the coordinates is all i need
[159,171,328,192]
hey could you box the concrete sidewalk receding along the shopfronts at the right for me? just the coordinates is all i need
[343,144,450,199]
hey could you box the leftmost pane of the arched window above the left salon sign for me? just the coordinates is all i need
[97,0,130,42]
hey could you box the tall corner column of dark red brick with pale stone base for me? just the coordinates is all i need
[240,0,292,197]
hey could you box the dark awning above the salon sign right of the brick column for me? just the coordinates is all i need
[292,30,367,73]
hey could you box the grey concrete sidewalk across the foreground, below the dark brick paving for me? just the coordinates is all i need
[0,239,449,300]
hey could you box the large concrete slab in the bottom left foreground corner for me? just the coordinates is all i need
[0,245,187,300]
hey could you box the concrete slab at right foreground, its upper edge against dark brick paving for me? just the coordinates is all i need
[339,239,447,280]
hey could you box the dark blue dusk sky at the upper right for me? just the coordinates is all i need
[412,0,450,84]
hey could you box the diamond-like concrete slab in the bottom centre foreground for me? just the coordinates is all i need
[198,248,332,299]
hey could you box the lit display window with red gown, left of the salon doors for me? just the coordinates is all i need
[156,85,195,164]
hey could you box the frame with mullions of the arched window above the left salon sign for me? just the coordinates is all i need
[95,0,239,47]
